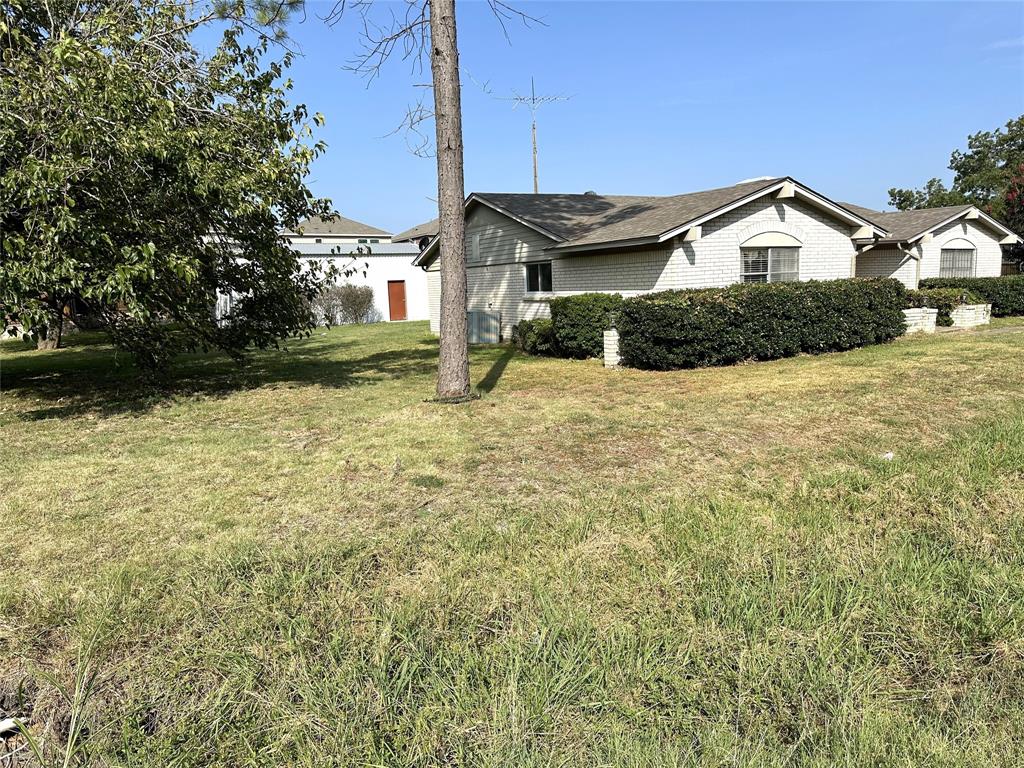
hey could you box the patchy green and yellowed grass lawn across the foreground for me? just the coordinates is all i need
[0,321,1024,768]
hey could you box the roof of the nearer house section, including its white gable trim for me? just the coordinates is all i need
[417,176,888,266]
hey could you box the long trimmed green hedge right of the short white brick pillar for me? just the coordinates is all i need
[617,278,906,371]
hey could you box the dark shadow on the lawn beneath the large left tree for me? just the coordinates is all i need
[0,337,437,421]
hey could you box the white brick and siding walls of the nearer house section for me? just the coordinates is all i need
[448,198,856,338]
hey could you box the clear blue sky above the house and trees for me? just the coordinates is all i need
[266,0,1024,231]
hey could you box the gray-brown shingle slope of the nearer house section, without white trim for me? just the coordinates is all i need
[475,178,782,249]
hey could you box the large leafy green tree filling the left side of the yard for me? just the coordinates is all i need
[0,0,330,370]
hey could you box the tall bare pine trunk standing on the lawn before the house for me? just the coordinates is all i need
[430,0,469,399]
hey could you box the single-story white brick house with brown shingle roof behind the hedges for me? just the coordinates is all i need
[416,177,1020,338]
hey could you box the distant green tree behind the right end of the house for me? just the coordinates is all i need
[889,115,1024,222]
